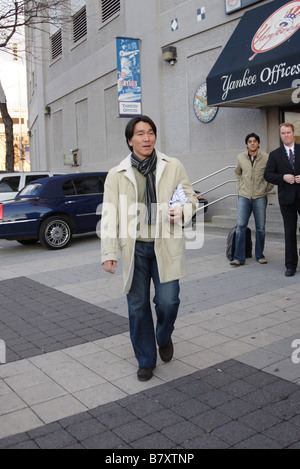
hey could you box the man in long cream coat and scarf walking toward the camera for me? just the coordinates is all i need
[101,116,198,381]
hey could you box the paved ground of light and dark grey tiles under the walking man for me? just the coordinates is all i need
[0,230,300,453]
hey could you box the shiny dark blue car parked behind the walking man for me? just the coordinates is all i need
[0,172,107,249]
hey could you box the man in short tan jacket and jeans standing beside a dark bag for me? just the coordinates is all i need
[230,133,273,267]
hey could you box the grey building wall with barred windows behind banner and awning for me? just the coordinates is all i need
[27,0,300,214]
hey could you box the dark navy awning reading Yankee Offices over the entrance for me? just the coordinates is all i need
[206,0,300,108]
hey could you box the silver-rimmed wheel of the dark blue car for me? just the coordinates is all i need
[40,216,72,249]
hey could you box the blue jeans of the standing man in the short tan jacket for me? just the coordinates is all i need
[234,196,268,263]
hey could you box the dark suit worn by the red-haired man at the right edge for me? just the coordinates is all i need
[264,144,300,270]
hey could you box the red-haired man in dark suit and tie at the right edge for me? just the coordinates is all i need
[264,123,300,277]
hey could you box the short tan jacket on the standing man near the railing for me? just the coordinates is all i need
[235,150,274,199]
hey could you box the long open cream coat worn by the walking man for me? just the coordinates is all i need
[101,151,198,293]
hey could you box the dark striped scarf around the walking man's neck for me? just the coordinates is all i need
[131,150,157,225]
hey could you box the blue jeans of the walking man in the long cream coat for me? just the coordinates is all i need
[127,241,180,368]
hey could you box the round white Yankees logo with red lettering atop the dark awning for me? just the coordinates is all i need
[249,0,300,60]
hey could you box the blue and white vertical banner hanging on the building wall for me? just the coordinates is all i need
[117,37,142,117]
